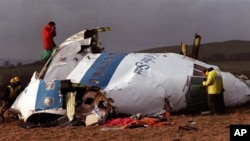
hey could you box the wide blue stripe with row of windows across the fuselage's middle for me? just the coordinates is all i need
[80,53,127,89]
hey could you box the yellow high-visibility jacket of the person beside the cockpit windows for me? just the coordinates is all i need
[202,70,223,94]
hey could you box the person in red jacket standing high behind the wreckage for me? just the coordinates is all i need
[41,21,56,61]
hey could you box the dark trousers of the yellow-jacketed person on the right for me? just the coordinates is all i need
[208,94,225,114]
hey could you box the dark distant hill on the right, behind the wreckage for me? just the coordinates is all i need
[138,40,250,61]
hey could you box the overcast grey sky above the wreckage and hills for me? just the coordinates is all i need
[0,0,250,60]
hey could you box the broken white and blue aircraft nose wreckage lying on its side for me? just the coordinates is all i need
[11,27,250,125]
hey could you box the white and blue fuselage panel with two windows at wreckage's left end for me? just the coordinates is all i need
[11,72,62,121]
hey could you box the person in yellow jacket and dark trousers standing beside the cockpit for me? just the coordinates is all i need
[202,68,225,114]
